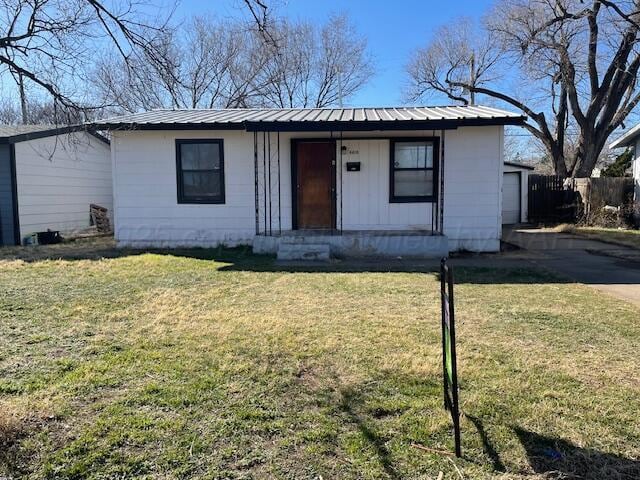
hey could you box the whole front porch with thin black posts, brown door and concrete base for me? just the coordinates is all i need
[253,129,449,260]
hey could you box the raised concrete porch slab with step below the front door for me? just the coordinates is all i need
[253,230,449,260]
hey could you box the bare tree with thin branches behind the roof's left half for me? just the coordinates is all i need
[94,17,262,112]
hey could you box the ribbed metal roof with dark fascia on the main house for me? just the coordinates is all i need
[93,105,526,131]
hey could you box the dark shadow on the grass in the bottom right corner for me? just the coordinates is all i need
[514,427,640,480]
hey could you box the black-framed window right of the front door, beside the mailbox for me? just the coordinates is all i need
[389,139,438,203]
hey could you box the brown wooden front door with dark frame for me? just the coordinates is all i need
[294,141,336,229]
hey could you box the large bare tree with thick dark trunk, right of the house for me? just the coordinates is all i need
[407,0,640,177]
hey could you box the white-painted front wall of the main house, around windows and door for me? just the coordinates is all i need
[111,127,503,251]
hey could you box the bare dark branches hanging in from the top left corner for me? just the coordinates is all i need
[0,0,178,120]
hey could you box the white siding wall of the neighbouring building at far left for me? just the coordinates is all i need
[15,132,113,238]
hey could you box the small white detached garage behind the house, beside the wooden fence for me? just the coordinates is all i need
[502,162,534,225]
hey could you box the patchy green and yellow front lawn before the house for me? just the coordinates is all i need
[0,242,640,479]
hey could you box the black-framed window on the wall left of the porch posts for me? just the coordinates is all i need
[176,140,224,203]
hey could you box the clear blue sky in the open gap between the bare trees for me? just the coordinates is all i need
[177,0,493,106]
